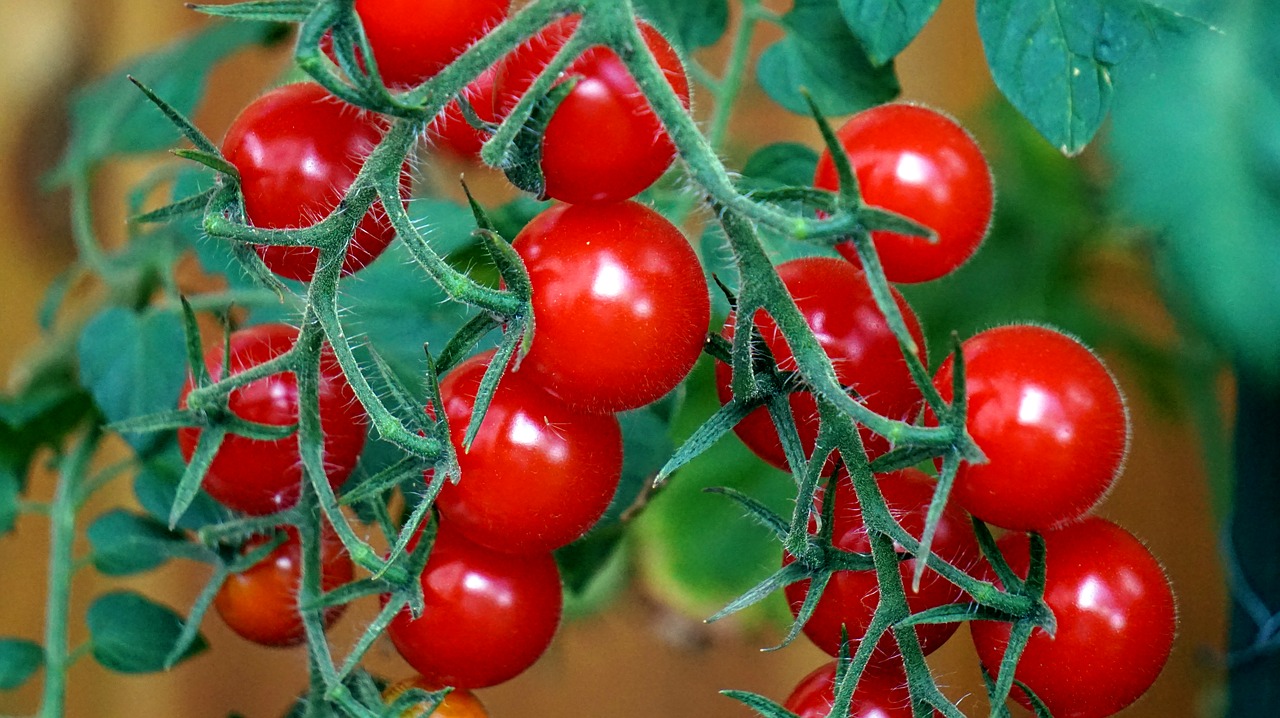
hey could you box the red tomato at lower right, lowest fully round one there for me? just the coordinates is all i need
[972,517,1178,718]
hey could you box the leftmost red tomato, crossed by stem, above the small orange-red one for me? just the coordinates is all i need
[178,324,369,516]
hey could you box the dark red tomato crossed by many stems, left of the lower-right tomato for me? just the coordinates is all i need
[782,468,979,663]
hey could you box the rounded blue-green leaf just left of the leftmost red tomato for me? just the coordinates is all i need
[77,307,187,454]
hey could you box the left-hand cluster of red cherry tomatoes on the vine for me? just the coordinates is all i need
[180,0,710,696]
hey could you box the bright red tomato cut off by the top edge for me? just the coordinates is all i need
[356,0,511,88]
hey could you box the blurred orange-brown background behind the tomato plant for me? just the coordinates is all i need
[0,0,1225,718]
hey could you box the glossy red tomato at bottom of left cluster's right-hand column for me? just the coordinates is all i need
[387,520,562,689]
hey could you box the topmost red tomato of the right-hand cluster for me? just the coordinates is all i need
[813,104,995,283]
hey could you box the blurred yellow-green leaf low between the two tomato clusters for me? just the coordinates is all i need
[632,361,795,623]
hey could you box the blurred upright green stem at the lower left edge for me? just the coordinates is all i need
[40,425,101,718]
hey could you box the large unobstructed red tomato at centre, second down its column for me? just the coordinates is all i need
[515,202,710,412]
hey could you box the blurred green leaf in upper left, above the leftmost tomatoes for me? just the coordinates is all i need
[52,23,275,184]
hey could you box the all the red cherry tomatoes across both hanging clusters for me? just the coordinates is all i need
[179,0,1174,718]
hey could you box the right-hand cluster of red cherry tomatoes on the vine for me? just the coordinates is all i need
[716,104,1175,717]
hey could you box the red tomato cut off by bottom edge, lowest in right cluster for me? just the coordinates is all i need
[783,660,941,718]
